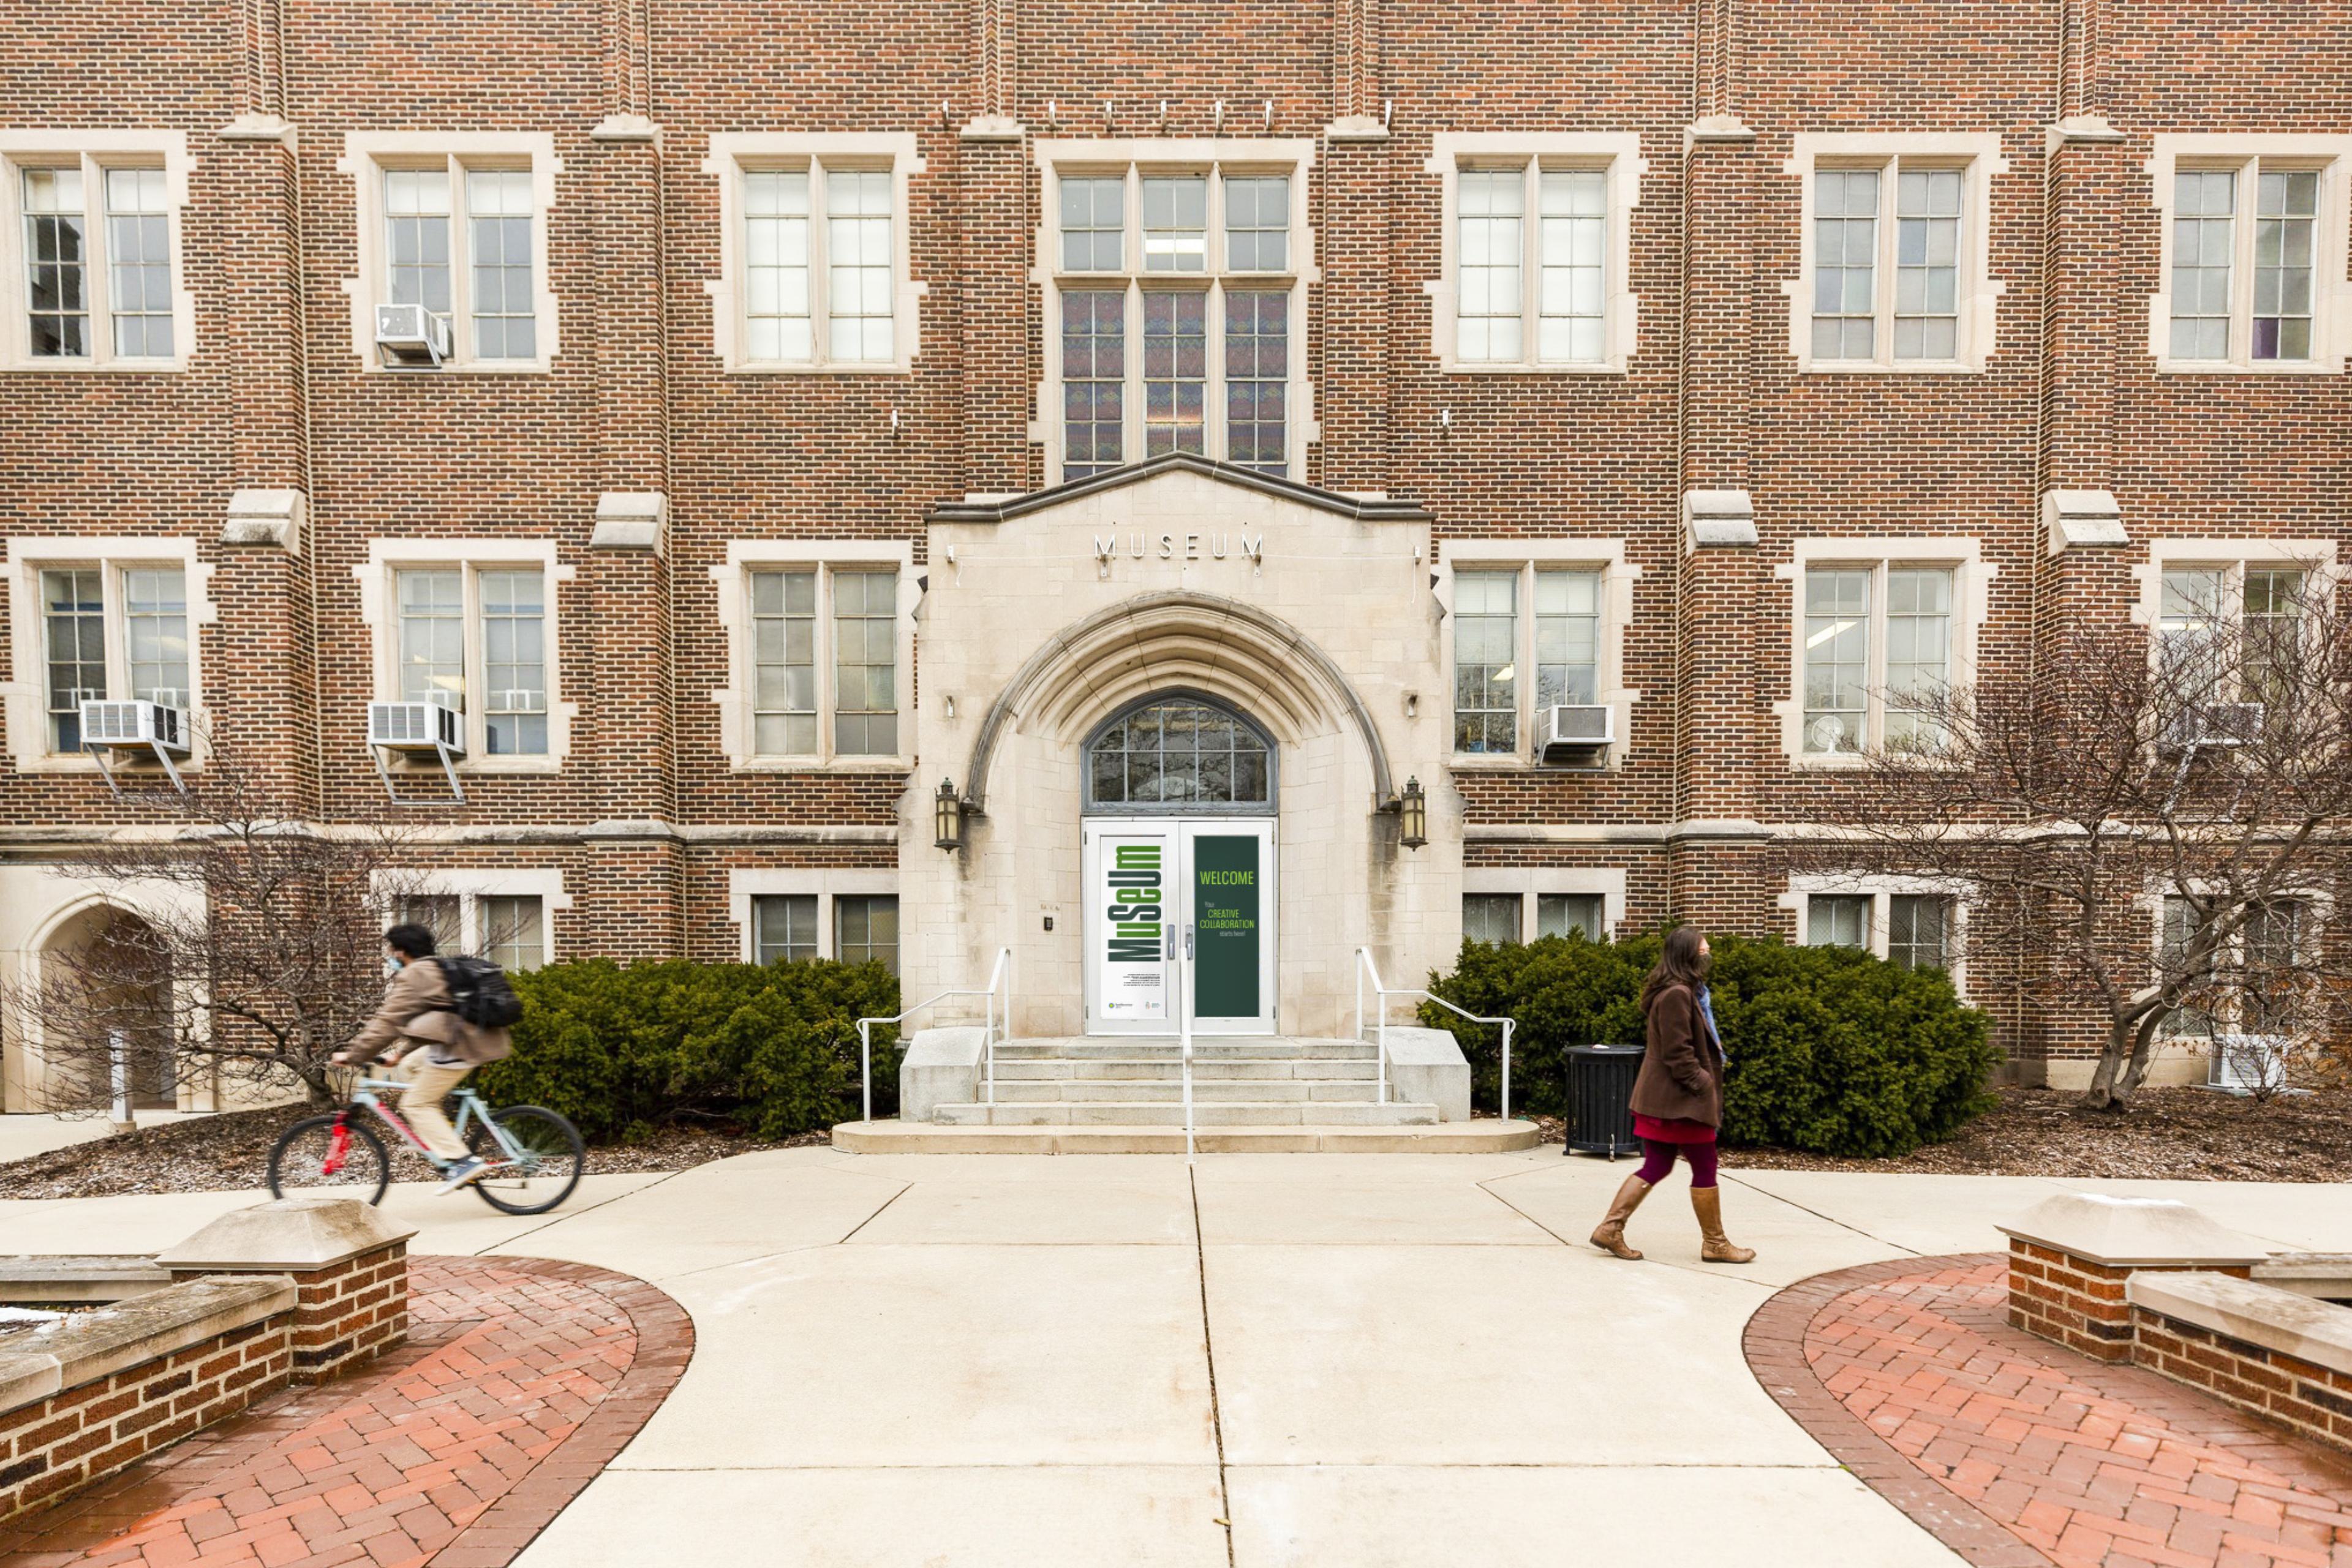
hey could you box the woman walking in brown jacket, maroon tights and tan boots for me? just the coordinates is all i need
[1593,926,1755,1262]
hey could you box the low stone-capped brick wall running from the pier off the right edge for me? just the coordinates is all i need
[2131,1274,2352,1450]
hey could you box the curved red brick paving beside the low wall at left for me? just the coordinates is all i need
[0,1257,694,1568]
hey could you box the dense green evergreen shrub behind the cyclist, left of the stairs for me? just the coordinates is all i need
[475,959,899,1142]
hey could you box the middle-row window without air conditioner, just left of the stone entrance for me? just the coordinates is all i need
[710,541,913,769]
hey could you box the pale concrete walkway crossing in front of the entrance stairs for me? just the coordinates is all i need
[0,1147,2352,1568]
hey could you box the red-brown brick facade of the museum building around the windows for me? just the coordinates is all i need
[0,0,2352,1072]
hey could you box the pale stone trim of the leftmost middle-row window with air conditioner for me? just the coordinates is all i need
[0,536,221,774]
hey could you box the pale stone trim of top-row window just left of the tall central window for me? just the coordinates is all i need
[701,132,932,376]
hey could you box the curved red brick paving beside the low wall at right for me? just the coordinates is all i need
[1747,1257,2352,1568]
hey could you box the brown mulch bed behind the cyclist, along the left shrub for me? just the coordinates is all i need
[0,1105,826,1199]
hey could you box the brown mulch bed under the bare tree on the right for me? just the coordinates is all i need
[1534,1088,2352,1183]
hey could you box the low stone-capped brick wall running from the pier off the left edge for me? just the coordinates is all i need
[0,1274,296,1521]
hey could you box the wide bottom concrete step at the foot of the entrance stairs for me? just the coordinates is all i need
[832,1117,1543,1154]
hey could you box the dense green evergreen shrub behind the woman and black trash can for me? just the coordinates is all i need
[1420,933,1999,1159]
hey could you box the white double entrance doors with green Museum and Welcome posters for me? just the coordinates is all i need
[1084,818,1275,1035]
